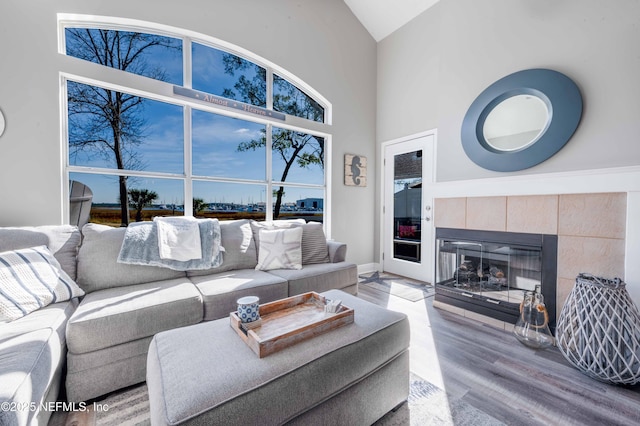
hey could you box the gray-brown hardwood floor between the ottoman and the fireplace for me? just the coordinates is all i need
[359,285,640,425]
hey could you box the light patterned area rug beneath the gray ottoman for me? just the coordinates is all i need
[84,373,503,426]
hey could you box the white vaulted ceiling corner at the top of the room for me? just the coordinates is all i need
[344,0,438,41]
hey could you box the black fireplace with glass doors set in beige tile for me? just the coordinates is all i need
[435,228,558,332]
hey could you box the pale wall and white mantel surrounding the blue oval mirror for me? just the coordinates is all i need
[376,0,640,303]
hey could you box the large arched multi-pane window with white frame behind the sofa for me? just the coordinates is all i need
[59,14,331,226]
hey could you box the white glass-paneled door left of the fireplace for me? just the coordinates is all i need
[382,135,434,282]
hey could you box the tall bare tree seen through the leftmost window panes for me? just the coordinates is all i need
[66,28,179,226]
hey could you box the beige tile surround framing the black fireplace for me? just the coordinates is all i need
[434,193,627,331]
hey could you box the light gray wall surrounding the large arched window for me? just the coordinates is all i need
[0,0,376,264]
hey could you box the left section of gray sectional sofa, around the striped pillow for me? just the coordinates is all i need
[0,225,80,426]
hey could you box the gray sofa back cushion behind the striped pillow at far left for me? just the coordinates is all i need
[0,225,81,280]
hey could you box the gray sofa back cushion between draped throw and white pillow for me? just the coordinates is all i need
[187,219,258,277]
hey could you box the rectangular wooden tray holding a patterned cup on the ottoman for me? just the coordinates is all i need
[229,292,353,358]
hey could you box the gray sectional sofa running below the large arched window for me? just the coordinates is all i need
[0,220,357,425]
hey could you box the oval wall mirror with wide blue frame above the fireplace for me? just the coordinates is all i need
[461,69,582,172]
